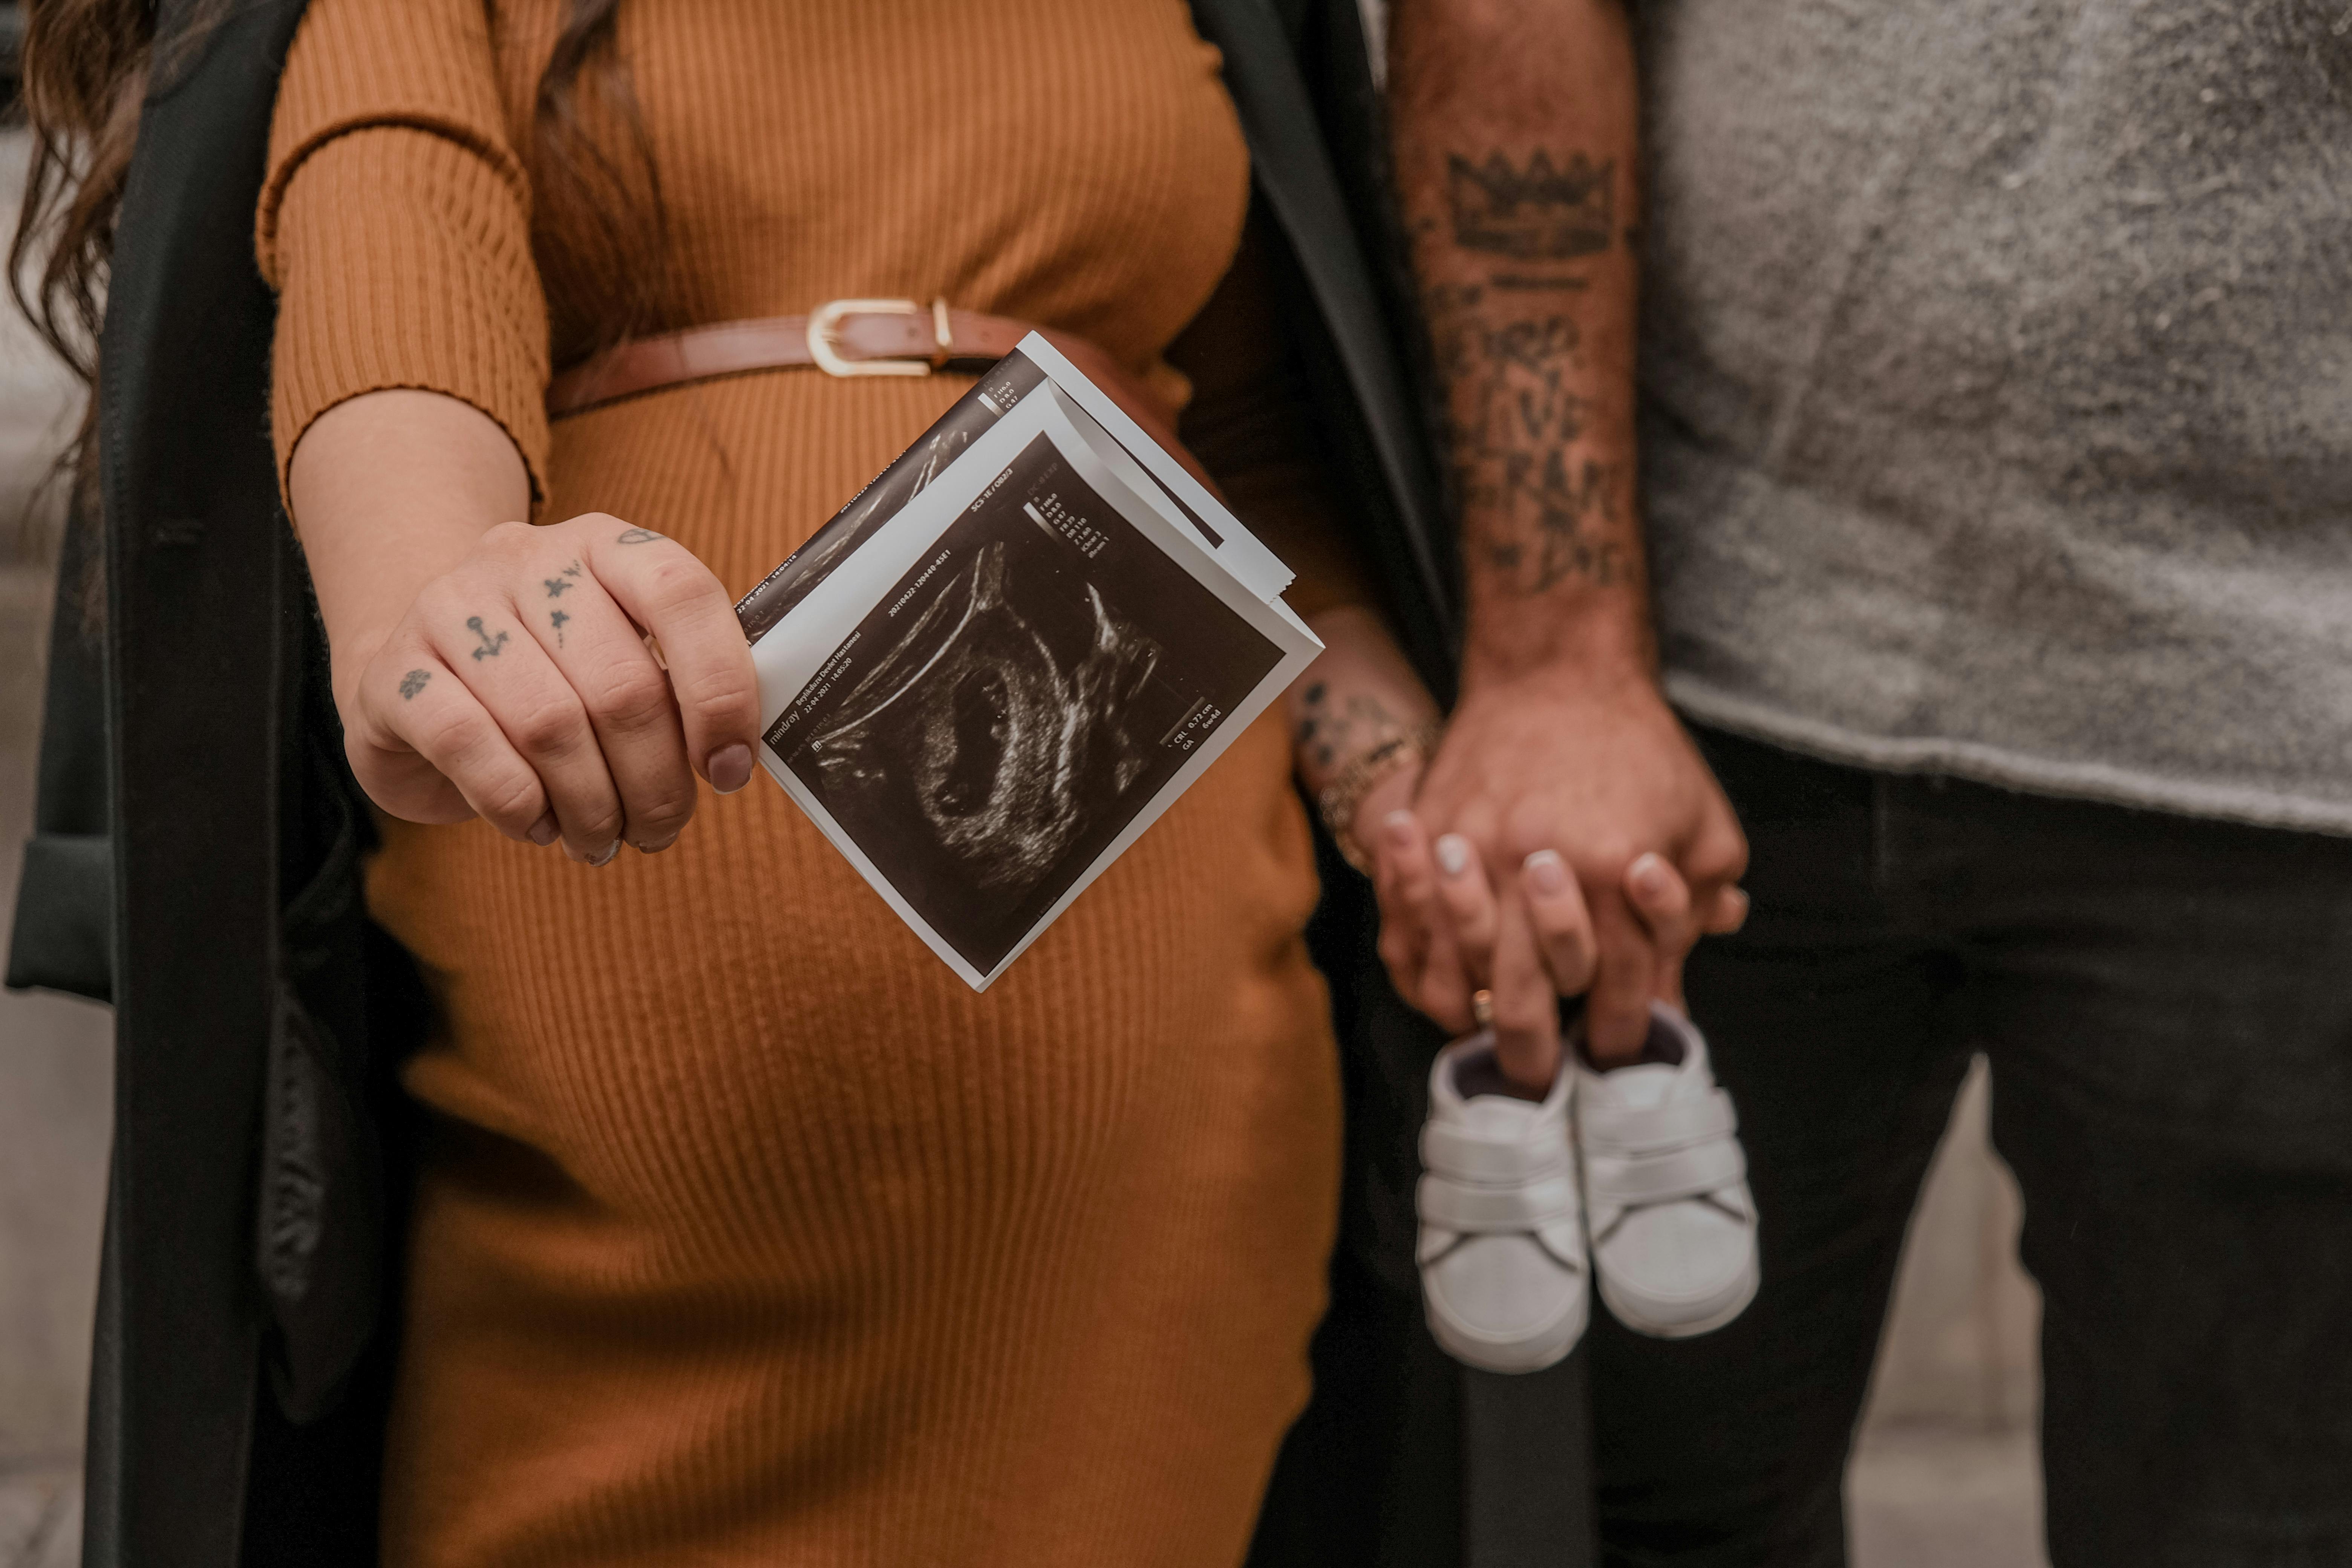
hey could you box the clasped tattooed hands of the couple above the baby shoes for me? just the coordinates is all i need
[1357,675,1747,1089]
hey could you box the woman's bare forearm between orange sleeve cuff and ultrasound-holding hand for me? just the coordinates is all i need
[287,390,531,698]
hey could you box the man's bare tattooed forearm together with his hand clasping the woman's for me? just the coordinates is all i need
[1390,0,1747,1081]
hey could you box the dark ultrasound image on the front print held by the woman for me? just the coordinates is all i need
[764,435,1286,973]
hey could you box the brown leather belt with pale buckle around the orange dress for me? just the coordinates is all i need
[548,299,1032,418]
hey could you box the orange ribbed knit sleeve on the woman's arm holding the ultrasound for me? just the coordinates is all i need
[256,0,548,496]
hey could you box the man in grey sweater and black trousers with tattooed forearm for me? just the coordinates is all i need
[1390,0,2352,1568]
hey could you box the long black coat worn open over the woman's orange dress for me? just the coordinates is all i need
[9,0,1580,1568]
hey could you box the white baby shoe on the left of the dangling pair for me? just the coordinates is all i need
[1418,1032,1590,1373]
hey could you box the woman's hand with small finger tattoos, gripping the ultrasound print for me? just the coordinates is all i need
[336,513,760,865]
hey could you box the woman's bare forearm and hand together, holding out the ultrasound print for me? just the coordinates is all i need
[287,393,760,865]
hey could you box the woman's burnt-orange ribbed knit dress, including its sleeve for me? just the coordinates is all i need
[259,0,1338,1568]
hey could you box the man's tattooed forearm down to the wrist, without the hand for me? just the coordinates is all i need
[1392,0,1649,672]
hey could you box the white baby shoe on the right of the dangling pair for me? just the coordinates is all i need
[1562,1001,1757,1340]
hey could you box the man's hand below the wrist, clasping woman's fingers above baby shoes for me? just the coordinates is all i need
[1413,668,1747,1081]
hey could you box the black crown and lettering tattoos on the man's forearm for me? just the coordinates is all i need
[1423,148,1637,595]
